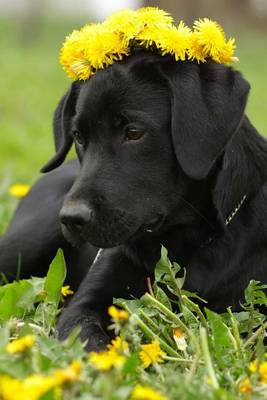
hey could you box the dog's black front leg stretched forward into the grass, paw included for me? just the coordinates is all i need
[58,246,149,350]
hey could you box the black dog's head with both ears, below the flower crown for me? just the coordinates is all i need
[43,51,249,247]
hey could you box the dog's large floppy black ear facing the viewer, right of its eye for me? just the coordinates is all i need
[161,61,249,179]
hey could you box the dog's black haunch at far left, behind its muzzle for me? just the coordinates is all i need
[0,161,78,280]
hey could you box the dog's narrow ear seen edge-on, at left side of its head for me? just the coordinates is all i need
[41,82,79,172]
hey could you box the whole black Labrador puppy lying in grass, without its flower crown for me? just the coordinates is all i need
[0,51,267,349]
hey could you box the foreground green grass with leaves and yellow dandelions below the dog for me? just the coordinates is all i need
[0,249,267,400]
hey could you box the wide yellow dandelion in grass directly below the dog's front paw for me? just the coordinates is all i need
[89,351,126,371]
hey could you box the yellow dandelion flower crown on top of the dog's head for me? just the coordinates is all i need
[60,7,237,80]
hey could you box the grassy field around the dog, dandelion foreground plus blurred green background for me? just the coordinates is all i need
[0,21,267,400]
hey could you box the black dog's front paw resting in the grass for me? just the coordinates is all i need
[57,308,110,351]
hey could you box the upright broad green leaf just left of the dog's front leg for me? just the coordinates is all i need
[44,249,66,306]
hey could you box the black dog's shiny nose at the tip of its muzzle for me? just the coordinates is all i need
[59,204,93,231]
